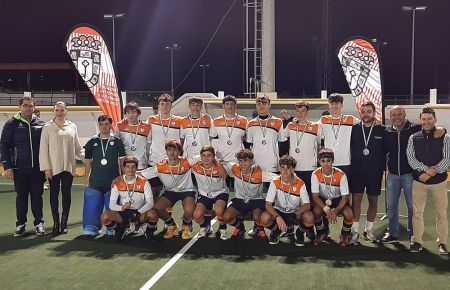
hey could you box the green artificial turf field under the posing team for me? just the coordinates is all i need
[0,177,450,289]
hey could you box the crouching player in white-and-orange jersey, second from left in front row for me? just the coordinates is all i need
[140,140,196,240]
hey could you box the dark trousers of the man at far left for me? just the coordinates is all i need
[14,168,45,226]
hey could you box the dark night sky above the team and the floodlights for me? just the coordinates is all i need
[0,0,450,96]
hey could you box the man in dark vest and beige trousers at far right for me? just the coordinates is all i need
[406,108,450,255]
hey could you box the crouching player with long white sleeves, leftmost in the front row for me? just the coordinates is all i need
[101,156,158,241]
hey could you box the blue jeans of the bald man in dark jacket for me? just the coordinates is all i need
[386,173,413,239]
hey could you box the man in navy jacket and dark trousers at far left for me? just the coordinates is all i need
[0,97,45,237]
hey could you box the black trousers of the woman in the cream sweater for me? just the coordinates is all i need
[49,171,73,217]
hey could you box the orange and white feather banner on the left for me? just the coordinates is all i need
[66,25,122,128]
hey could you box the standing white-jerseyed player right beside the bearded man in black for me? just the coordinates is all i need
[318,94,360,178]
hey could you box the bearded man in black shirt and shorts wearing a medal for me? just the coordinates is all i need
[349,102,386,245]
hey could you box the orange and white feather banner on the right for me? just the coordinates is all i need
[338,38,383,121]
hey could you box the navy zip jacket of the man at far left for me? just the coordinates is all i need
[0,113,45,170]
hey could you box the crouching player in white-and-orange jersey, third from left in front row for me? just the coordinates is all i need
[192,145,228,240]
